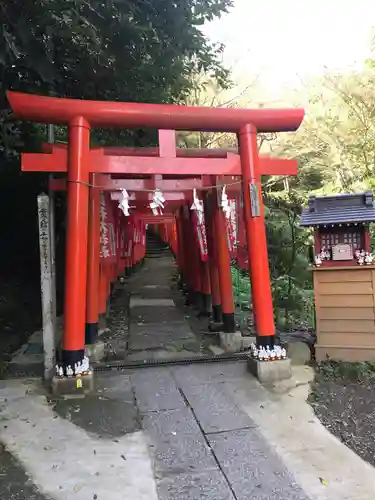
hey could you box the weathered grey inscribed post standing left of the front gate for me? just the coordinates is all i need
[38,193,56,380]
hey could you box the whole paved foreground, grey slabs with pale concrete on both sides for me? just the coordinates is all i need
[0,362,375,500]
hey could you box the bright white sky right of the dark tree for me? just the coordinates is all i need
[205,0,375,98]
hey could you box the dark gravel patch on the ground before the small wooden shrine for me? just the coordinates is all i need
[309,363,375,466]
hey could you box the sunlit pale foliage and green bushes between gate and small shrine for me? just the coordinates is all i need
[264,55,375,326]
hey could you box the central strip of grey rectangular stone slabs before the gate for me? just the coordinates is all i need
[132,363,308,500]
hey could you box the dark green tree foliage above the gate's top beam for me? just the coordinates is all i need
[0,0,231,102]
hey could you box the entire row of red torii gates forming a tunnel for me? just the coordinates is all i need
[7,92,304,368]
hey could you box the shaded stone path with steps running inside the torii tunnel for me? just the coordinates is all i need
[105,252,212,362]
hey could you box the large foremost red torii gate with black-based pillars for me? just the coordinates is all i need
[7,92,304,372]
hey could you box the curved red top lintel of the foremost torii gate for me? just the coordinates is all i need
[6,91,304,132]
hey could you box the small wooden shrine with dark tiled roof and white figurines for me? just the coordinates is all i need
[300,192,375,362]
